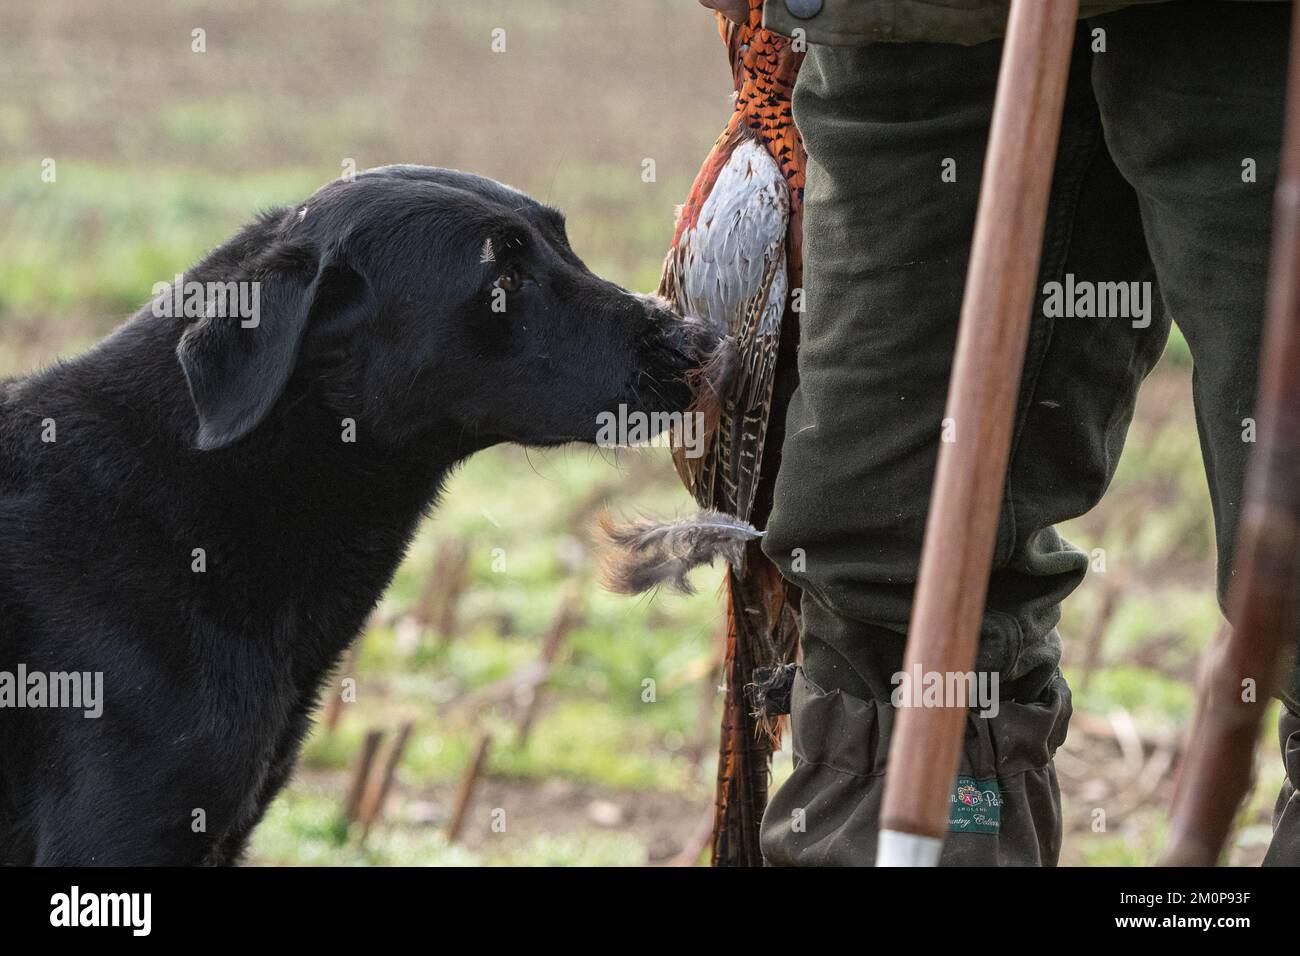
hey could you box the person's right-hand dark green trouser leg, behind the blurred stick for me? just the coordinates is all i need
[1093,3,1300,865]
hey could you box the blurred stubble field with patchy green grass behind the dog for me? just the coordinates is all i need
[0,0,1281,865]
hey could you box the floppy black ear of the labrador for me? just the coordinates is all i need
[177,248,369,451]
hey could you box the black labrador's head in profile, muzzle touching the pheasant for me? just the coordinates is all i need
[177,166,715,450]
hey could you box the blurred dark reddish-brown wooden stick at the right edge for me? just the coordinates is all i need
[1164,8,1300,866]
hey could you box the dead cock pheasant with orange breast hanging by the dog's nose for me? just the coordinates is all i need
[659,0,805,866]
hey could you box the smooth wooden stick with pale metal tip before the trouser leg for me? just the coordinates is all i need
[876,0,1079,866]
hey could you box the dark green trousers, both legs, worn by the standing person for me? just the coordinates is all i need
[763,3,1300,864]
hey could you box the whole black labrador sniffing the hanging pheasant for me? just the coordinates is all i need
[0,166,715,865]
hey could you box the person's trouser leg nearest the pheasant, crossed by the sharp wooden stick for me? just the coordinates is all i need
[763,34,1167,865]
